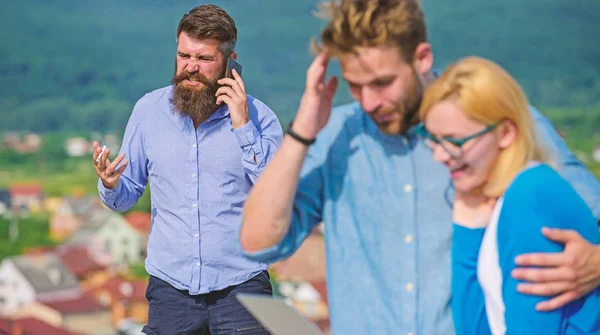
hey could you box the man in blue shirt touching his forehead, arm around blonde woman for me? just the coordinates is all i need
[240,0,600,335]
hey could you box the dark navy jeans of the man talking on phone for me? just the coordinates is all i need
[142,271,273,335]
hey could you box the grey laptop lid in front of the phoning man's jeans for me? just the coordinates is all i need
[236,293,323,335]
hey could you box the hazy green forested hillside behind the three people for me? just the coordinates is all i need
[0,0,600,132]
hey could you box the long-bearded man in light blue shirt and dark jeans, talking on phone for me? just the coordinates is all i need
[93,5,283,335]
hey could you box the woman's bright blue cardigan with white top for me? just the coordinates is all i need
[452,164,600,335]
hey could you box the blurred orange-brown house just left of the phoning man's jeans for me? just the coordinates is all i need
[90,276,148,328]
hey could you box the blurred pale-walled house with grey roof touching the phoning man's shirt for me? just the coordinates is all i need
[66,209,143,266]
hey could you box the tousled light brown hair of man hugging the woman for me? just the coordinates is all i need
[312,0,427,62]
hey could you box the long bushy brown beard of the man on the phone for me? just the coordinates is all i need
[170,66,225,125]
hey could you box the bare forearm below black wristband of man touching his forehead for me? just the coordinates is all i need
[240,136,308,252]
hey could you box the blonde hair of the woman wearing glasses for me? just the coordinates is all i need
[419,57,551,197]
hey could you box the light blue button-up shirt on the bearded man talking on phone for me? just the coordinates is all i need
[98,86,283,294]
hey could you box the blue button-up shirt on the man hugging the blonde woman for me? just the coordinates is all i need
[248,103,600,335]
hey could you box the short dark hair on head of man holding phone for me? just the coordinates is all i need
[177,5,237,56]
